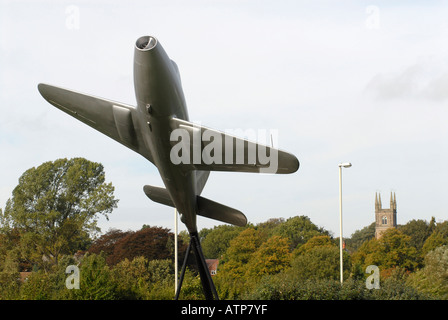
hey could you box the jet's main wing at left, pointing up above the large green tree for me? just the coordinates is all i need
[38,83,152,162]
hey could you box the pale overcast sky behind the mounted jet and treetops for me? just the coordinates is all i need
[0,0,448,236]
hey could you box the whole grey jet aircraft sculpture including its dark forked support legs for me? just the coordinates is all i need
[38,36,299,299]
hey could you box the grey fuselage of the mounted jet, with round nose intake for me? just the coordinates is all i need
[134,36,198,232]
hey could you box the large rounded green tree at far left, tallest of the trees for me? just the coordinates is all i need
[1,158,118,266]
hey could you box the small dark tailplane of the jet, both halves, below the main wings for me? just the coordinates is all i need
[143,185,247,227]
